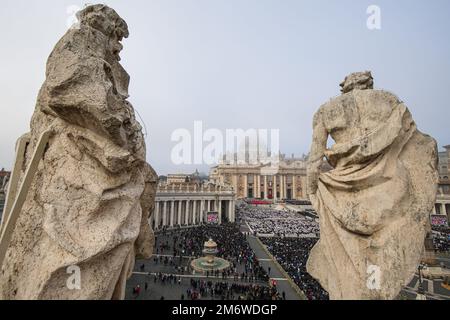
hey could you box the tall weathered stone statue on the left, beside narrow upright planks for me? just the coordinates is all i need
[0,5,157,299]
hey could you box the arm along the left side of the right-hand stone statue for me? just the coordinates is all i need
[307,111,328,195]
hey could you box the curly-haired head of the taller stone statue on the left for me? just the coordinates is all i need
[77,4,129,60]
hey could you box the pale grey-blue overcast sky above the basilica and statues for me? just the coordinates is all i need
[0,0,450,174]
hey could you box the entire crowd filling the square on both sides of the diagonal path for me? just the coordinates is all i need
[126,202,450,300]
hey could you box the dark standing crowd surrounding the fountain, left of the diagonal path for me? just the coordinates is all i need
[132,224,284,300]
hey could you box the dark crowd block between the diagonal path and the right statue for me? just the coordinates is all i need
[261,238,329,300]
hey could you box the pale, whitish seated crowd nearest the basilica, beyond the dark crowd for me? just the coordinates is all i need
[237,205,320,238]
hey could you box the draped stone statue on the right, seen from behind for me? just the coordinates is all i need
[307,72,438,299]
